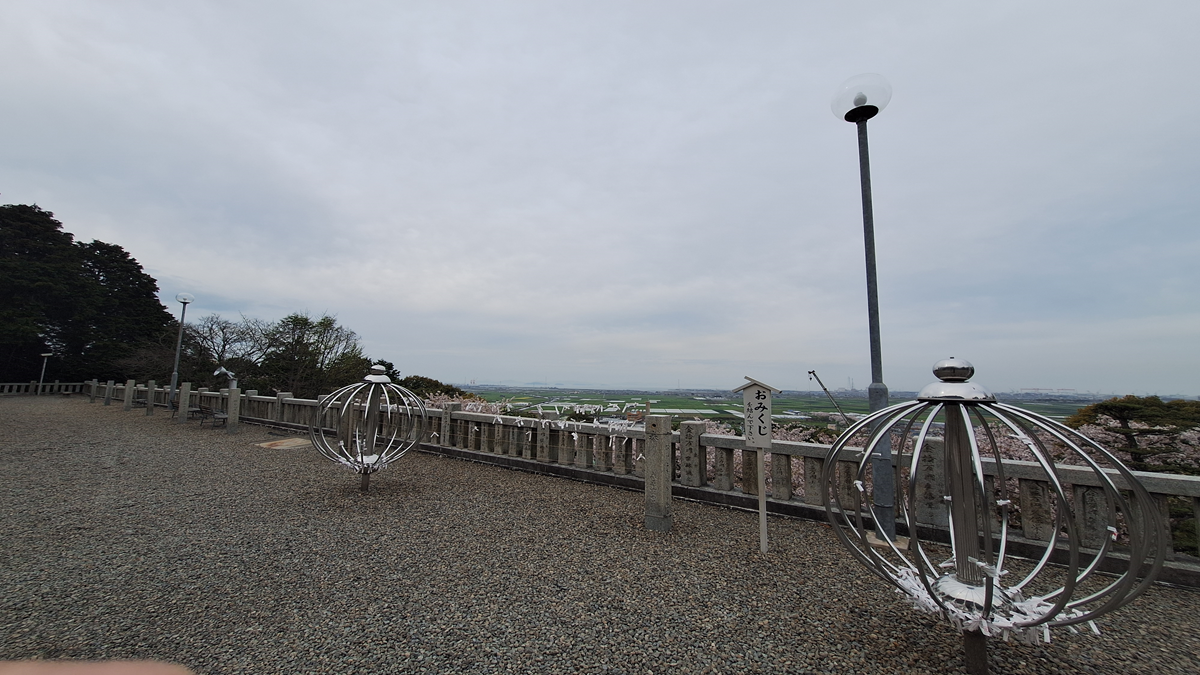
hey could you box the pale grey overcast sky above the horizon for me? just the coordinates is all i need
[0,0,1200,395]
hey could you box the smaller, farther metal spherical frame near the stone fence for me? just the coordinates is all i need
[308,374,426,478]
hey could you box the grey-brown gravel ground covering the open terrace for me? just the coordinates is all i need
[0,398,1200,675]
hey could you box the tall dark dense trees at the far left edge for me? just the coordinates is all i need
[0,204,178,382]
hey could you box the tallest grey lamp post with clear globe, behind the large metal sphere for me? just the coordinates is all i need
[832,73,896,540]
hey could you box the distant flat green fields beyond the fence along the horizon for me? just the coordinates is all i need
[464,387,1086,422]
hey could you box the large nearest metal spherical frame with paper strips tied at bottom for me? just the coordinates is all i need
[822,382,1169,643]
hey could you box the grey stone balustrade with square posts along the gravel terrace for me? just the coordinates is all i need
[42,381,1200,586]
